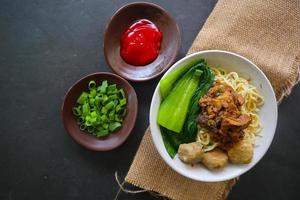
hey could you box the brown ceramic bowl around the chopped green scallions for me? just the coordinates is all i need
[62,72,138,151]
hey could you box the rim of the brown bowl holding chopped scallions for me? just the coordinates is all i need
[61,72,138,151]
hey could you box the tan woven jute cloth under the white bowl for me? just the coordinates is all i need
[125,0,300,200]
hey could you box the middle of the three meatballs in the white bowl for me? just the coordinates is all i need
[202,149,228,170]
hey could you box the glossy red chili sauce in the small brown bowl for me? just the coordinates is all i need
[120,19,162,66]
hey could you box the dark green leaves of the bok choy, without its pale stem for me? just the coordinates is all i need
[158,59,214,158]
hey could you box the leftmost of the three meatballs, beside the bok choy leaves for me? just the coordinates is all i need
[178,142,203,164]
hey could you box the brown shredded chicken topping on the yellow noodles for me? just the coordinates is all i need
[198,81,251,149]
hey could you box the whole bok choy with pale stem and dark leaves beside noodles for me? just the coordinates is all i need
[157,59,214,158]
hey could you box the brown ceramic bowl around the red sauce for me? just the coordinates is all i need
[104,2,181,81]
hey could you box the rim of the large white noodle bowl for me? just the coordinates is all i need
[149,49,278,182]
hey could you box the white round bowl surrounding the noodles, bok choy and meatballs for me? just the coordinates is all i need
[150,50,277,182]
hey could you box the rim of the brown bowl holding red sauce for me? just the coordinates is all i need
[102,2,181,82]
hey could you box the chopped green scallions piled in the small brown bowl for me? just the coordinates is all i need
[72,80,127,137]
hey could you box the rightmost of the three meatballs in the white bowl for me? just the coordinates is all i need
[228,140,253,164]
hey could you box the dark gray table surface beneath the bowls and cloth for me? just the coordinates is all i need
[0,0,300,200]
